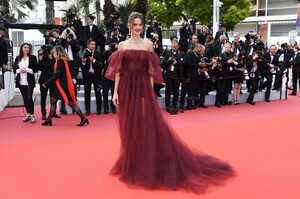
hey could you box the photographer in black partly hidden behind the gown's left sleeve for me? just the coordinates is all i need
[101,43,118,114]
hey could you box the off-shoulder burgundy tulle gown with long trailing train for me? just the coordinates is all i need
[106,50,236,193]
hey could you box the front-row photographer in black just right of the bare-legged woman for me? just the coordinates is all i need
[247,51,262,105]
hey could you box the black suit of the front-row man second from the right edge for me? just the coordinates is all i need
[260,53,279,100]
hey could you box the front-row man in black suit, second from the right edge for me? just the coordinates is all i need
[259,45,279,102]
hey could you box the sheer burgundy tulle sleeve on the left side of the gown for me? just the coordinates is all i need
[105,51,124,81]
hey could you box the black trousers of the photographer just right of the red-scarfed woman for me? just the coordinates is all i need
[84,74,102,111]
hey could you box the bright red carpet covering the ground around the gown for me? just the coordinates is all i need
[0,96,300,199]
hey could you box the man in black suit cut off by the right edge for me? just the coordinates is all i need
[290,46,300,95]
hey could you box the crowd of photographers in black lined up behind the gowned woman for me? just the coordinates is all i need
[34,12,300,116]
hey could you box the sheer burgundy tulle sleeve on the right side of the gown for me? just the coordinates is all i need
[148,52,164,83]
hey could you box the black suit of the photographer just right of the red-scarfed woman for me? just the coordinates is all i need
[81,51,102,112]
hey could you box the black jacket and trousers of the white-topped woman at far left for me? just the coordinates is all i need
[13,55,38,114]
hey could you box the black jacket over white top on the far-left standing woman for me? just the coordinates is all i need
[13,55,38,88]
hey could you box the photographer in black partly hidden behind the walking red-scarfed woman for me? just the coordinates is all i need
[38,44,60,120]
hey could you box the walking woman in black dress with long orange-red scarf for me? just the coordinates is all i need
[42,45,89,126]
